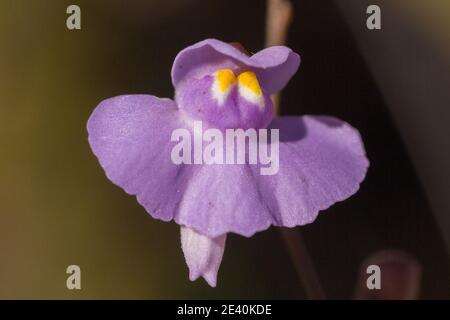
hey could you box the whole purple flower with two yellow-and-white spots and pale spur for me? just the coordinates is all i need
[87,39,368,286]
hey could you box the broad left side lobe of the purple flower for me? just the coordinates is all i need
[87,95,188,221]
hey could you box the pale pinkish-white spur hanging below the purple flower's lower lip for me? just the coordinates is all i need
[180,226,227,287]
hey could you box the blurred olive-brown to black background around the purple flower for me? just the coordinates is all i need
[0,0,450,299]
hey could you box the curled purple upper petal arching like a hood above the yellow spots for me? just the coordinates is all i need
[172,39,300,94]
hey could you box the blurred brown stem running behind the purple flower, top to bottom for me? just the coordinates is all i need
[266,0,325,299]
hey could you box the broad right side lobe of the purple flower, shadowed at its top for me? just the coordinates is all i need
[253,116,369,227]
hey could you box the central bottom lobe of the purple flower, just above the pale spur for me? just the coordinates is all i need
[175,164,273,238]
